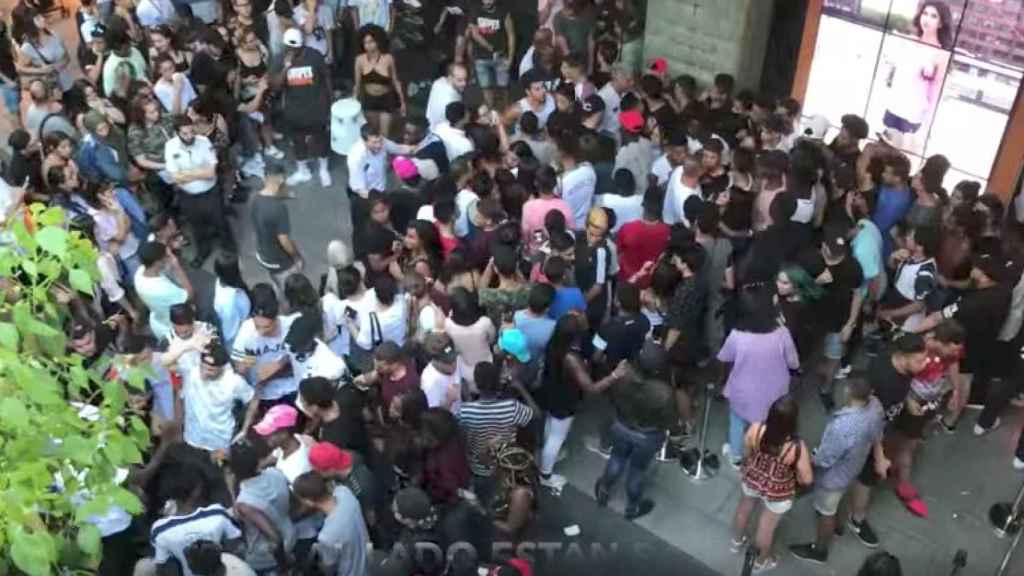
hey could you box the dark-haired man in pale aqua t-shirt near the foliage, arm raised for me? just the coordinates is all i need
[133,242,194,339]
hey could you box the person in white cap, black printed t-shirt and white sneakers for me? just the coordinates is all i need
[281,28,332,189]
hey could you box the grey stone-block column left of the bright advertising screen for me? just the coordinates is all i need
[644,0,775,88]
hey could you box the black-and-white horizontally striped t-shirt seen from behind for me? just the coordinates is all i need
[456,400,534,477]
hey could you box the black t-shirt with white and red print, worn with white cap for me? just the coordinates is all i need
[284,48,331,126]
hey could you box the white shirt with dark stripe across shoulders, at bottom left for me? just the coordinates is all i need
[150,504,242,576]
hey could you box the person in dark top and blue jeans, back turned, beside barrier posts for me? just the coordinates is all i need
[594,341,678,520]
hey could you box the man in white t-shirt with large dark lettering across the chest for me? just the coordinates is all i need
[231,283,299,404]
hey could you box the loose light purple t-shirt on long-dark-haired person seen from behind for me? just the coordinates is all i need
[718,327,800,422]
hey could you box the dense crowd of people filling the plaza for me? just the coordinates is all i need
[0,0,1024,576]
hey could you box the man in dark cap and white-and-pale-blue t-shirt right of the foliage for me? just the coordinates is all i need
[161,334,259,453]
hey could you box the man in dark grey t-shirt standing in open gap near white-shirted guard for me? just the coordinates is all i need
[251,167,305,290]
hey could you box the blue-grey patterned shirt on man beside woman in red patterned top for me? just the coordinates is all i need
[813,396,886,491]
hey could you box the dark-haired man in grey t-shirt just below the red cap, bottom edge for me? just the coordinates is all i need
[292,471,370,576]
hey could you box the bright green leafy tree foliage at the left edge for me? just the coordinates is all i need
[0,205,150,576]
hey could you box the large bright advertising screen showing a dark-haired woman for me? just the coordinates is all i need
[804,0,1024,180]
